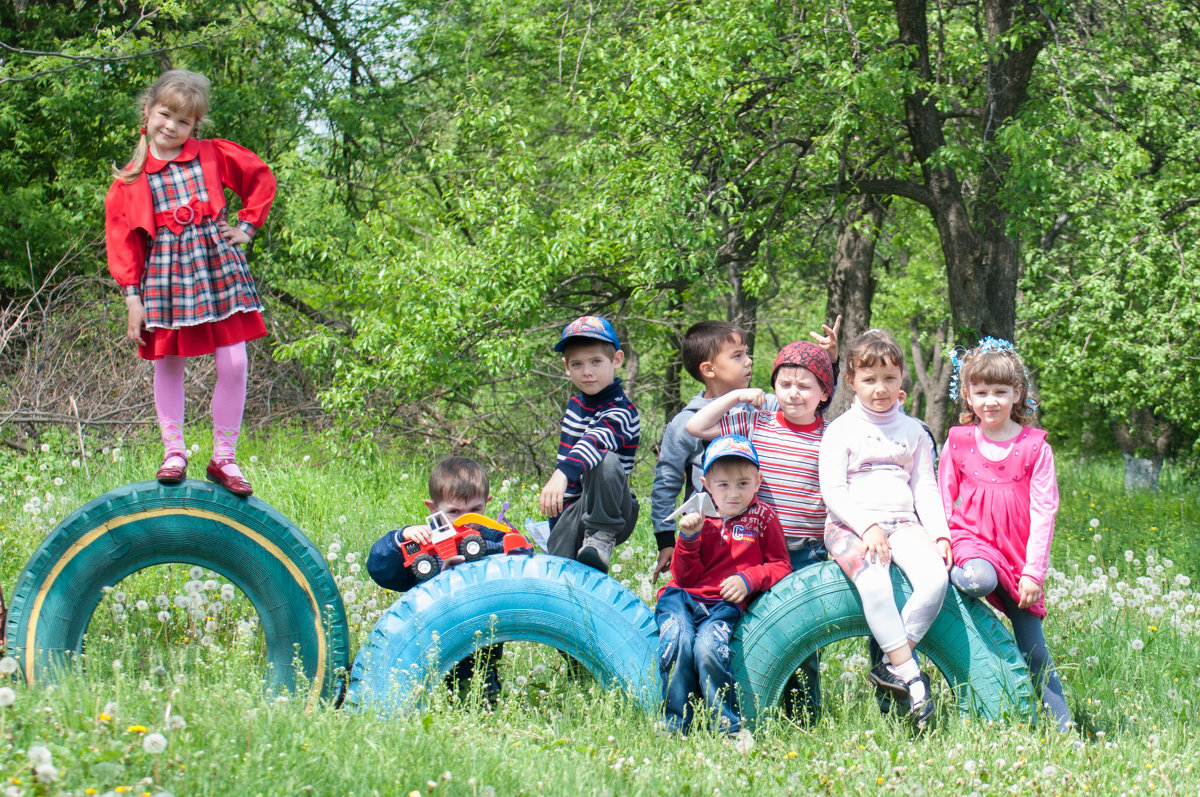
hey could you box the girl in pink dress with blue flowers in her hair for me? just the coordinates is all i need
[938,337,1070,731]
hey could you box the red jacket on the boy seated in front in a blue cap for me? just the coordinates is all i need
[659,498,792,611]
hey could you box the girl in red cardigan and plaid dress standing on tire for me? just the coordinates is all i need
[104,70,275,496]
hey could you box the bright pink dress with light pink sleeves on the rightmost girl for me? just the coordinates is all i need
[938,426,1058,617]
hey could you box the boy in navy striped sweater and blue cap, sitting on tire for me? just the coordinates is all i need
[538,316,641,573]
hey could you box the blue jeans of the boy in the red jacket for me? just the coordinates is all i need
[654,587,742,733]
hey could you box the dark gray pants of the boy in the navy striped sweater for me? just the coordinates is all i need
[546,451,638,559]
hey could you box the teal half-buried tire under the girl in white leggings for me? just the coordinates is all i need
[733,562,1037,720]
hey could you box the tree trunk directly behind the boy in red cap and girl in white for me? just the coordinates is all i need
[826,194,888,418]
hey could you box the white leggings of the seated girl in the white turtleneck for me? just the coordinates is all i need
[826,525,948,652]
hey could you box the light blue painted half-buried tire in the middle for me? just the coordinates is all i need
[346,555,660,713]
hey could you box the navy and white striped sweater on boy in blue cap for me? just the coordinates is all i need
[556,378,642,508]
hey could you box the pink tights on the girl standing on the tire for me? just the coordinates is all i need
[154,342,250,475]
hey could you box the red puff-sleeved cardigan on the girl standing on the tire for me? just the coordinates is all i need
[104,138,275,287]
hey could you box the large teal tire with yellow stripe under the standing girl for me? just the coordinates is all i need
[7,480,349,700]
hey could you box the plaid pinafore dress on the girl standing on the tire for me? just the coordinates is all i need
[142,157,265,331]
